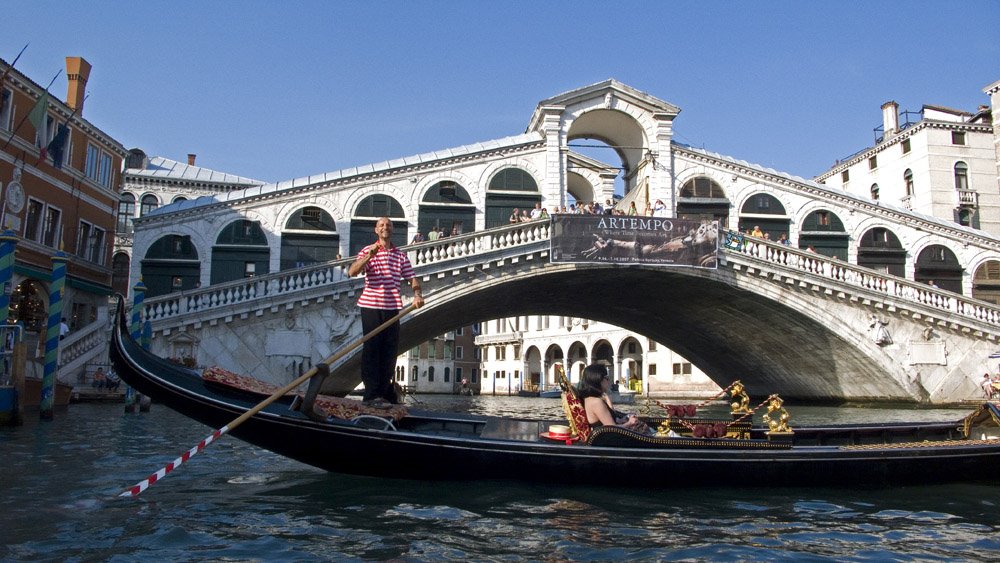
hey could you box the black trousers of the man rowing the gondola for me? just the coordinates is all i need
[360,307,399,402]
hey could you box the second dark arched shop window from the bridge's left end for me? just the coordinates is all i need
[210,219,271,284]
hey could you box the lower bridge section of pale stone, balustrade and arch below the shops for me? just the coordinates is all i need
[127,220,1000,402]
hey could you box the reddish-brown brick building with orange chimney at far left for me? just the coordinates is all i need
[0,57,126,349]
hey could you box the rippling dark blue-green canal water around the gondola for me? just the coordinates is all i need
[0,397,1000,562]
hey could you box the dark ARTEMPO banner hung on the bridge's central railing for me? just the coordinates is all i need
[549,214,719,268]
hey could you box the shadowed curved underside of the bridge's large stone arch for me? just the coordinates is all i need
[318,264,925,401]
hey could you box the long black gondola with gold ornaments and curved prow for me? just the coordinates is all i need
[110,300,1000,487]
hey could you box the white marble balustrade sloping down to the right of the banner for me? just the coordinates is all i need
[723,231,1000,325]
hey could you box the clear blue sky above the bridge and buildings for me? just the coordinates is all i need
[0,0,1000,181]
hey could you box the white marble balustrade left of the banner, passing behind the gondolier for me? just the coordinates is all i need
[144,221,550,323]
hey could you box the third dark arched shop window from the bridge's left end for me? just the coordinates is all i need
[280,206,340,270]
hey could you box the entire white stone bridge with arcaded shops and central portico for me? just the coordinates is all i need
[111,80,1000,402]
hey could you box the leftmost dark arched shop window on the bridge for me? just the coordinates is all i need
[141,235,201,297]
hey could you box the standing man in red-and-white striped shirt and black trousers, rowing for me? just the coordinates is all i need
[348,217,424,406]
